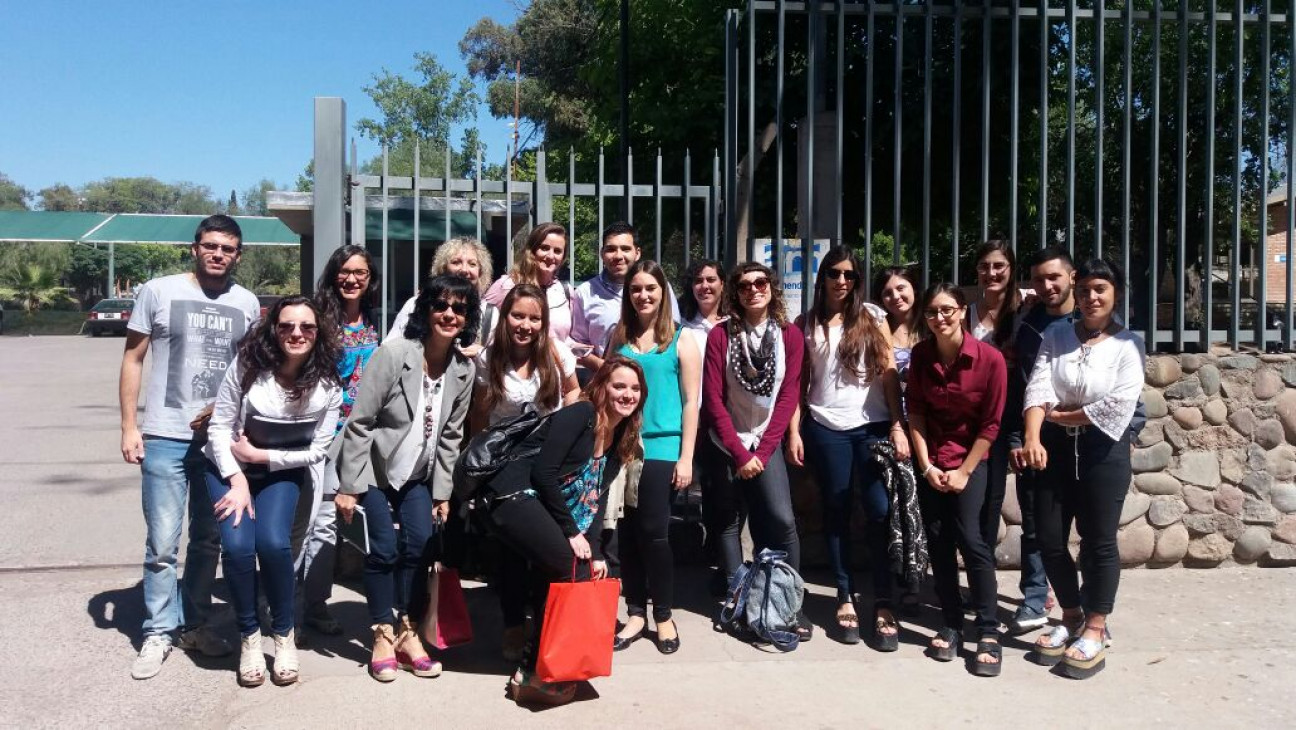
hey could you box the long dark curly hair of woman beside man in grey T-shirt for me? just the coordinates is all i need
[238,294,342,401]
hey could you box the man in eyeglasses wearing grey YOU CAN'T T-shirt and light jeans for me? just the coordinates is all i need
[118,215,260,679]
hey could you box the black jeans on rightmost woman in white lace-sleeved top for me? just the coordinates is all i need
[1034,423,1130,615]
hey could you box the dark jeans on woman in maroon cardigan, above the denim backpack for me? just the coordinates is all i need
[706,450,801,580]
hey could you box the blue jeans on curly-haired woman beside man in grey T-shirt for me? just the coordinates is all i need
[207,463,308,637]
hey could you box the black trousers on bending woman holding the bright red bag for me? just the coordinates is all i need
[485,495,599,672]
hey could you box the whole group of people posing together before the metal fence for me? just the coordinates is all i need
[121,215,1143,704]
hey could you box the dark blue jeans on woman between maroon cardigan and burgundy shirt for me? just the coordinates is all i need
[802,415,894,606]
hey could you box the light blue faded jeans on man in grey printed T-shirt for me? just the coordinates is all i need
[140,436,220,637]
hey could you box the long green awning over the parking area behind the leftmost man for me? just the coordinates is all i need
[0,210,298,246]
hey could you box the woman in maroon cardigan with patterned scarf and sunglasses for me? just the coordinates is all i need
[702,262,813,641]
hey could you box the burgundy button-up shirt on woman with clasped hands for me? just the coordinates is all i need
[905,332,1008,471]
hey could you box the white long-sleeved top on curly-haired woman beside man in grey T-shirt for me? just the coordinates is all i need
[203,358,342,478]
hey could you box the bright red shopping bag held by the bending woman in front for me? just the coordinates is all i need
[535,567,621,682]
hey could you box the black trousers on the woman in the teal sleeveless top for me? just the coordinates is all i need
[617,459,675,622]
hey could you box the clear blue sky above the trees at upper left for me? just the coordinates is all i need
[0,0,517,206]
